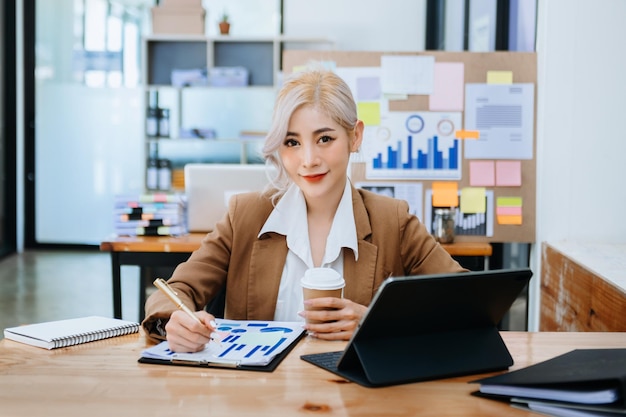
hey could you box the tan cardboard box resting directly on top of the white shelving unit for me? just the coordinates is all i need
[152,6,206,35]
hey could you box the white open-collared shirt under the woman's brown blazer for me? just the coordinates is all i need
[259,181,359,321]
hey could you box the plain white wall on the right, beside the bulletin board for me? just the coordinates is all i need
[530,0,626,329]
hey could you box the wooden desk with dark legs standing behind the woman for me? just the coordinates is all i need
[100,233,492,320]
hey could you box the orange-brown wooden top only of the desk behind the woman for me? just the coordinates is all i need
[100,233,492,256]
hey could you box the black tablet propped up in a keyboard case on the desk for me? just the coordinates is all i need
[301,268,532,387]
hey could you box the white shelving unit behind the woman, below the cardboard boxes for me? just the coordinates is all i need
[142,35,334,188]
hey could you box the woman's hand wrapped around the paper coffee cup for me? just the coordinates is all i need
[298,297,367,340]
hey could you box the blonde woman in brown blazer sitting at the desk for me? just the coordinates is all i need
[143,70,464,352]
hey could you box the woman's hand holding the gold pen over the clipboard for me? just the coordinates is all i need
[165,310,216,352]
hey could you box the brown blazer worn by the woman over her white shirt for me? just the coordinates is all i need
[142,187,465,338]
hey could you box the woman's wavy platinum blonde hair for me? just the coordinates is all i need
[262,66,358,201]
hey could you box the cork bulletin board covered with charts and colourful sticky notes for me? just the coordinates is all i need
[282,50,537,243]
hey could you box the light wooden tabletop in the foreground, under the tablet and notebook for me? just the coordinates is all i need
[0,332,626,417]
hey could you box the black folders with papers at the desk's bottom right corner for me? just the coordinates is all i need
[472,349,626,417]
